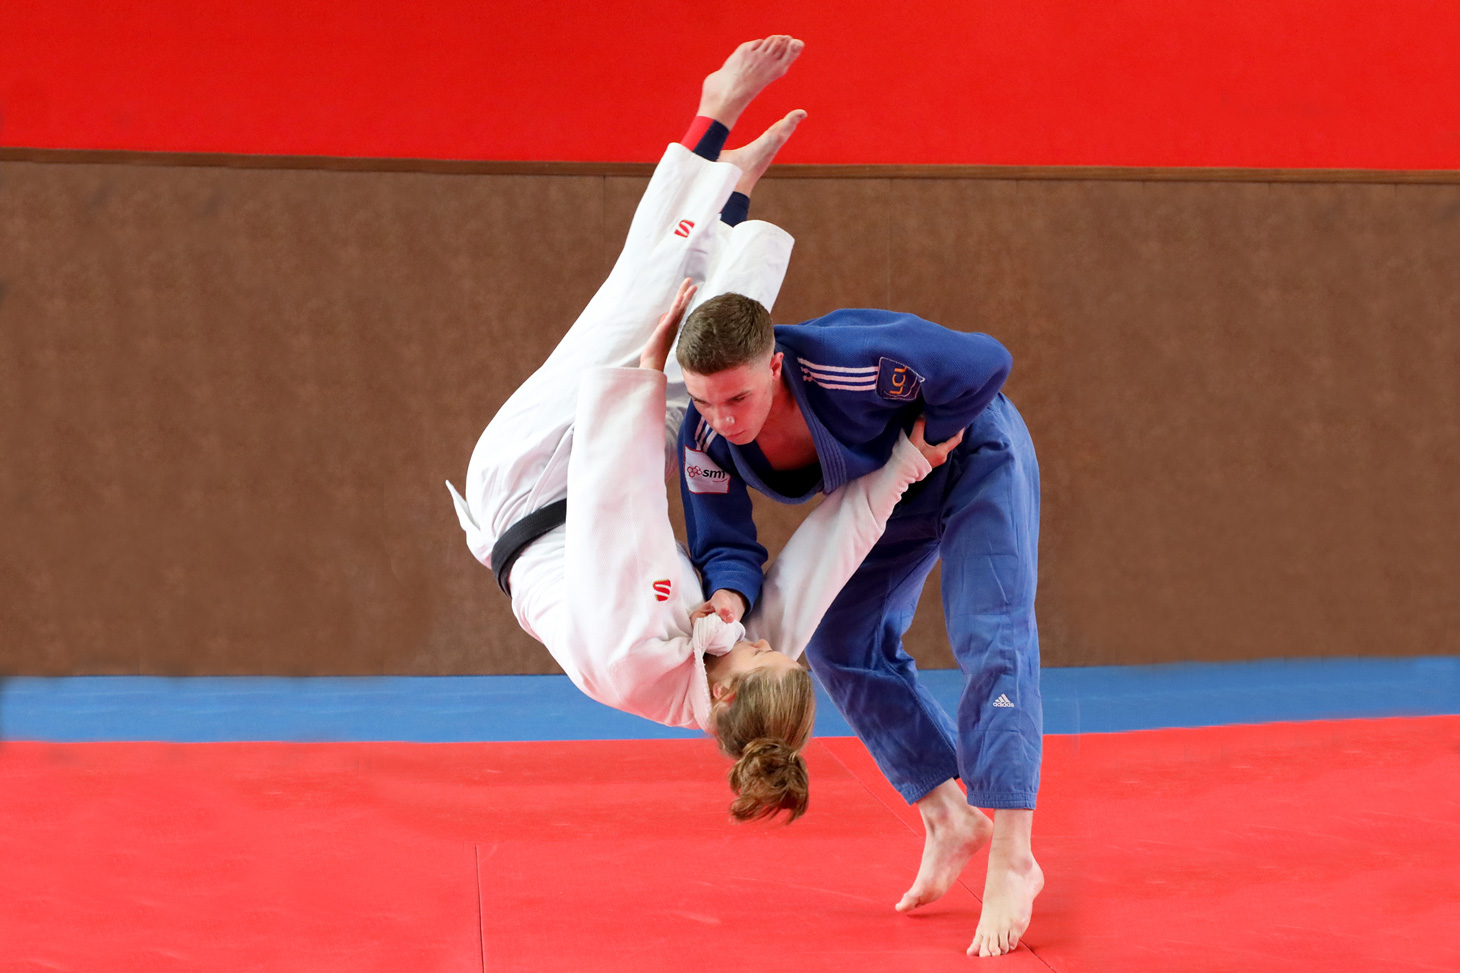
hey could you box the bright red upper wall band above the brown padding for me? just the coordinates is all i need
[0,0,1460,169]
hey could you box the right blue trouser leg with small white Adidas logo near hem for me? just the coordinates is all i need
[939,396,1044,808]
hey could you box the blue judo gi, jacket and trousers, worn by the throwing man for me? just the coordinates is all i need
[679,308,1044,808]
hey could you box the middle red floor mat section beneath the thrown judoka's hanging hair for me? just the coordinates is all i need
[480,741,1047,973]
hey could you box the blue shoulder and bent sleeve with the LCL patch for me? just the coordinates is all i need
[821,310,1013,443]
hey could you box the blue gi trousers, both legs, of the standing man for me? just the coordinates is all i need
[806,394,1044,808]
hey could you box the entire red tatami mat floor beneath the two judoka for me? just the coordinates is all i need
[0,717,1460,973]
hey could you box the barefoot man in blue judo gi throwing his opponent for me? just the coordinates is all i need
[677,294,1044,955]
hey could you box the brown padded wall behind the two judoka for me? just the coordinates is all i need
[0,162,1460,675]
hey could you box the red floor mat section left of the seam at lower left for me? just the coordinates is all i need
[0,742,480,973]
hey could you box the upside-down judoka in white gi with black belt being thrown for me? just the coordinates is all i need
[447,35,958,820]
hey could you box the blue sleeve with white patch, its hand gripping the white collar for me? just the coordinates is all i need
[679,406,765,609]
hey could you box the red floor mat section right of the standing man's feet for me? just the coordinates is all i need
[1022,716,1460,973]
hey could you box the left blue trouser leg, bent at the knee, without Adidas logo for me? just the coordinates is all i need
[806,520,958,804]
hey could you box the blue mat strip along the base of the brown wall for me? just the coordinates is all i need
[0,656,1460,742]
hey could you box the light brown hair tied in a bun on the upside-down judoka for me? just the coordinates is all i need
[711,668,816,824]
